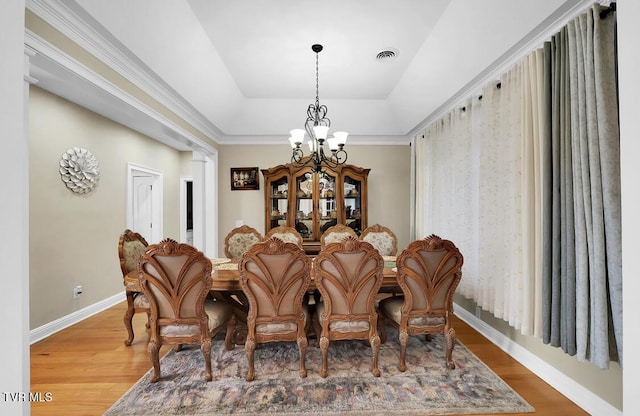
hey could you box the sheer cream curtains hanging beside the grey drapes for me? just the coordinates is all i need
[416,51,544,336]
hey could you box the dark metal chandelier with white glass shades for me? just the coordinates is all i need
[289,44,349,172]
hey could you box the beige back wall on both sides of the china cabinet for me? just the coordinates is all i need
[218,142,411,256]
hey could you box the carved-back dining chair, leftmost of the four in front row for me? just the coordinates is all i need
[138,239,234,383]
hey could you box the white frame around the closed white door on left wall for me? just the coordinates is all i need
[126,163,163,244]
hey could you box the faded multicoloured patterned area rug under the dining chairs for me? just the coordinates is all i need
[105,328,534,416]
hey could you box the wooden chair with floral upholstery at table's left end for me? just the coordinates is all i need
[118,229,149,346]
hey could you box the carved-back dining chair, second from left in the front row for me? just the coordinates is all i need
[240,237,311,381]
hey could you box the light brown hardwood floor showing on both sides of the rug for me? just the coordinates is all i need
[31,302,588,416]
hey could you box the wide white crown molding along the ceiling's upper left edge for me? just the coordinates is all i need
[26,0,224,142]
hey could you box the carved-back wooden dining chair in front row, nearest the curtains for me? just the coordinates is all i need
[378,235,463,371]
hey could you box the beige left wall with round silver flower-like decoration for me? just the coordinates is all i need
[29,87,185,329]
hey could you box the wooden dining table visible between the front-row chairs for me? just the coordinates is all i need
[211,256,401,345]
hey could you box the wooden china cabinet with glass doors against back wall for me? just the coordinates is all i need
[262,159,370,254]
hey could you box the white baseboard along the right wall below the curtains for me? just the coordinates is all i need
[454,304,622,416]
